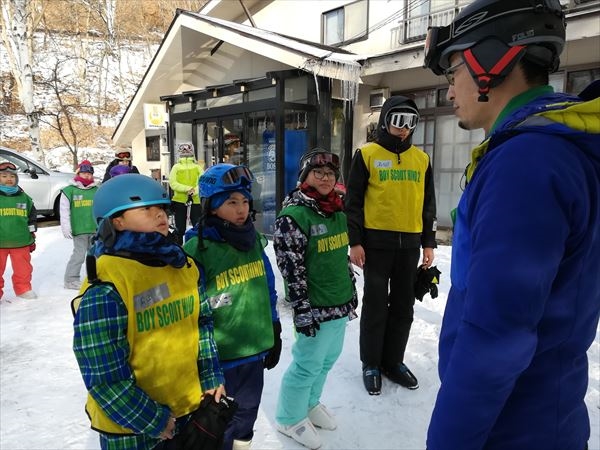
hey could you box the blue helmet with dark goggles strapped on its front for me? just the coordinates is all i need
[198,163,254,200]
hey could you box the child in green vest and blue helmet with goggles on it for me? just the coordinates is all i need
[184,164,281,450]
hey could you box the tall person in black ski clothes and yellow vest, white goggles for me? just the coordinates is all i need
[345,96,436,395]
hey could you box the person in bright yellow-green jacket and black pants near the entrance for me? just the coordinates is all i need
[169,142,202,244]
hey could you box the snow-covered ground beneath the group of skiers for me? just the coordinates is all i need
[0,226,600,450]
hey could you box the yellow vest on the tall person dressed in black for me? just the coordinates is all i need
[360,142,429,233]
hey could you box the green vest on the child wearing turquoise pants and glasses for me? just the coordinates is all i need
[279,206,353,306]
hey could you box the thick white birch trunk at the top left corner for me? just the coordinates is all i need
[1,0,45,161]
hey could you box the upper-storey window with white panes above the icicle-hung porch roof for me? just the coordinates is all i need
[321,0,369,45]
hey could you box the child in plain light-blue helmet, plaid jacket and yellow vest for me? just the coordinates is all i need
[73,174,224,450]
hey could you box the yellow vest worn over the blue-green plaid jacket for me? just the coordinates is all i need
[82,255,202,434]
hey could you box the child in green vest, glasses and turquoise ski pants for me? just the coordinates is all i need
[273,148,358,449]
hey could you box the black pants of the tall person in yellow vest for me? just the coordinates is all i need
[360,248,421,367]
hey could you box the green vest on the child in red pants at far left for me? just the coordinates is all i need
[0,191,33,248]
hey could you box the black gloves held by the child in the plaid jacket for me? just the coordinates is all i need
[170,394,238,450]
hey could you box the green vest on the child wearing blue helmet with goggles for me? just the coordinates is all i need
[184,235,273,361]
